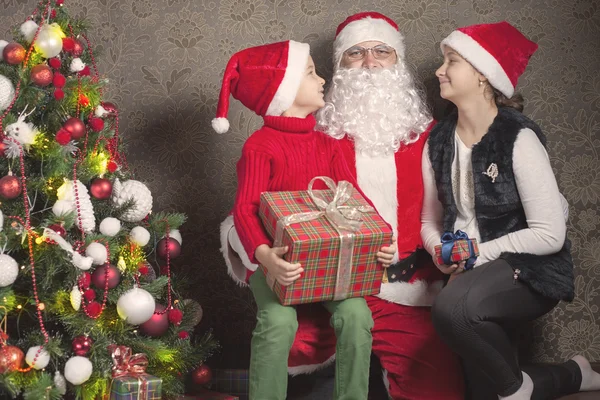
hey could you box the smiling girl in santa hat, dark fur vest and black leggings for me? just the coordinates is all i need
[421,22,600,400]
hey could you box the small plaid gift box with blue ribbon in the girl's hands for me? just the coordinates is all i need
[435,231,479,269]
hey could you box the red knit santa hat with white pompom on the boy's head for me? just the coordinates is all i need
[212,40,310,133]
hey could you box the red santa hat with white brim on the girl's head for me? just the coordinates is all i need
[440,21,538,97]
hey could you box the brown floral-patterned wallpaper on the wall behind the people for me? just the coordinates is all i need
[0,0,600,367]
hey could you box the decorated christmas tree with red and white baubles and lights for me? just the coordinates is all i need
[0,0,216,399]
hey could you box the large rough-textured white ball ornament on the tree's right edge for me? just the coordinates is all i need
[112,178,152,222]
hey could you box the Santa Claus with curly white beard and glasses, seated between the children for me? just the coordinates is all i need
[221,12,463,400]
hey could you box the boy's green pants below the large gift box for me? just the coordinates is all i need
[250,269,373,400]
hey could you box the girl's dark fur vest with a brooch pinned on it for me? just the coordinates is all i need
[428,107,575,301]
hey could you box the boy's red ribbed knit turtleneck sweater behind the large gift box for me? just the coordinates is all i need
[233,115,372,264]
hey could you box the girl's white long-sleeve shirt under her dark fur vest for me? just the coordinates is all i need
[421,129,568,266]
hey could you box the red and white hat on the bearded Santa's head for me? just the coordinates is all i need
[333,12,404,69]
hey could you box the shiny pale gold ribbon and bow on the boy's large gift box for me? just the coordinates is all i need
[274,176,375,300]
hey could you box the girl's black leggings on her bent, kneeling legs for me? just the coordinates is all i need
[432,260,581,400]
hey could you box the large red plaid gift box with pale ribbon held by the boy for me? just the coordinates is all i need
[259,177,392,305]
